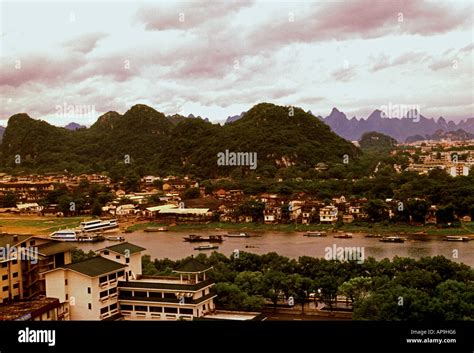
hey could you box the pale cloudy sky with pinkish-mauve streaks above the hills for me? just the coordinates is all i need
[0,0,474,126]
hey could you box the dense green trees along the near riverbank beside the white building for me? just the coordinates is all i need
[142,252,474,321]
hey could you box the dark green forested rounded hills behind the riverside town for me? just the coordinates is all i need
[0,103,360,177]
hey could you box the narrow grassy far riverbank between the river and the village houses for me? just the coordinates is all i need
[126,222,474,235]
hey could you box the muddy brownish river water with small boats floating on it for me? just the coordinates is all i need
[76,230,474,267]
